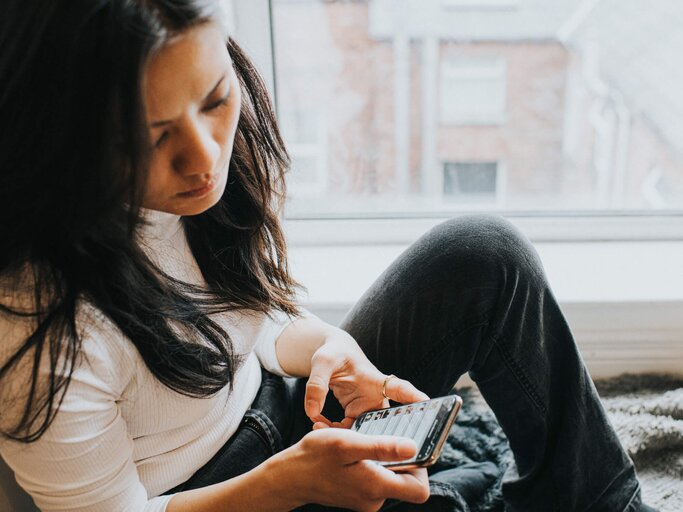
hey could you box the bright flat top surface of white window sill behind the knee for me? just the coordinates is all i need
[289,241,683,304]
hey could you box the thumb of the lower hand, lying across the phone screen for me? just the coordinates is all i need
[337,430,417,464]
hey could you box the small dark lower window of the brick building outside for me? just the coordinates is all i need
[443,162,501,203]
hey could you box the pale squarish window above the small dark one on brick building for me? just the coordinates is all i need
[440,57,506,125]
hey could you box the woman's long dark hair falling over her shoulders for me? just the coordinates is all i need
[0,0,299,442]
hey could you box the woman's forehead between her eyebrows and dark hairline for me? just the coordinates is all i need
[143,23,230,116]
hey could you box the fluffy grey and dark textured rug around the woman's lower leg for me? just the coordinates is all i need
[430,375,683,512]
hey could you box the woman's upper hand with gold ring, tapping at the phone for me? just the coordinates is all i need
[304,329,429,429]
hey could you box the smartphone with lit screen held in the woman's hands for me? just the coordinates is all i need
[351,395,462,469]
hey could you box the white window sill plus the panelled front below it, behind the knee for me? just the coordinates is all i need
[289,241,683,376]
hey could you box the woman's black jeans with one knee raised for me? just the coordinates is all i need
[168,216,641,512]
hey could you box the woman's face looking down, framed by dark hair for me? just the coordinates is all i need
[142,23,241,215]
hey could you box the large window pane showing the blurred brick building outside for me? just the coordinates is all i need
[273,0,683,217]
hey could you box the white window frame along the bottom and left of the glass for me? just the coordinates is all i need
[233,0,683,246]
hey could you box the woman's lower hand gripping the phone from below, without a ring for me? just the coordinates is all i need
[265,428,429,512]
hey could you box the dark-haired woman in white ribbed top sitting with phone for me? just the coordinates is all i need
[0,0,652,512]
